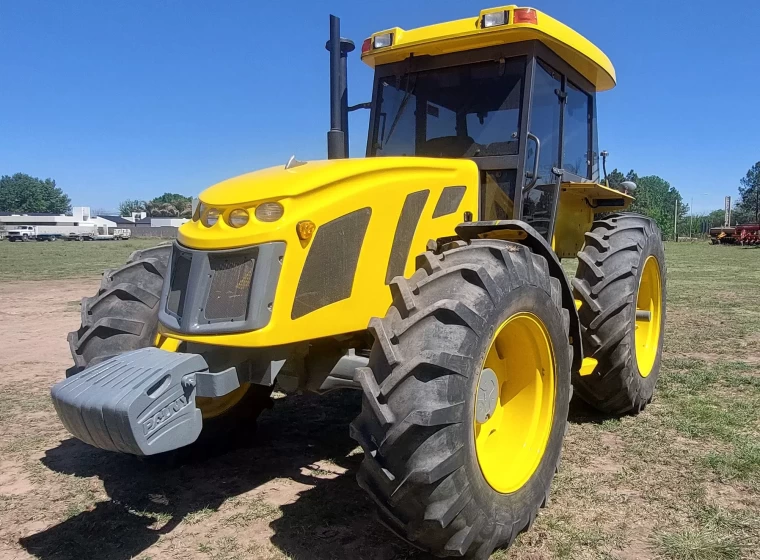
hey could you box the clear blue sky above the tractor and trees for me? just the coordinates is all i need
[0,0,760,212]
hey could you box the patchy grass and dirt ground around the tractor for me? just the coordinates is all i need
[0,238,760,560]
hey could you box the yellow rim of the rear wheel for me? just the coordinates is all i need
[634,255,662,377]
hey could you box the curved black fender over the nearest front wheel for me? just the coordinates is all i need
[455,220,584,372]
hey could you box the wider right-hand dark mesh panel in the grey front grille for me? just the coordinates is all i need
[203,253,255,321]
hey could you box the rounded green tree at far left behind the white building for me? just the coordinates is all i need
[0,173,71,214]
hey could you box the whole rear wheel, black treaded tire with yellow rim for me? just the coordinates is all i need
[573,213,666,414]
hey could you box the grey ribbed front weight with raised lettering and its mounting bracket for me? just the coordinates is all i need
[51,348,240,455]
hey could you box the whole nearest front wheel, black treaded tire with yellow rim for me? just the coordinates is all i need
[351,240,572,558]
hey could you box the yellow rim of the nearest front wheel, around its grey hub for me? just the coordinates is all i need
[474,313,556,494]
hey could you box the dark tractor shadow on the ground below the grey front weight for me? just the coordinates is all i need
[19,391,427,560]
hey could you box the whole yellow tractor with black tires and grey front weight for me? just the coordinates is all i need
[52,6,665,558]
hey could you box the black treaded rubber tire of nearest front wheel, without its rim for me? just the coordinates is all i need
[351,240,572,558]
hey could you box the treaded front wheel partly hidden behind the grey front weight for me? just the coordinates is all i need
[66,244,272,447]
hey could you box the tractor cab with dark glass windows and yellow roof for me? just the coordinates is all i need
[362,6,628,252]
